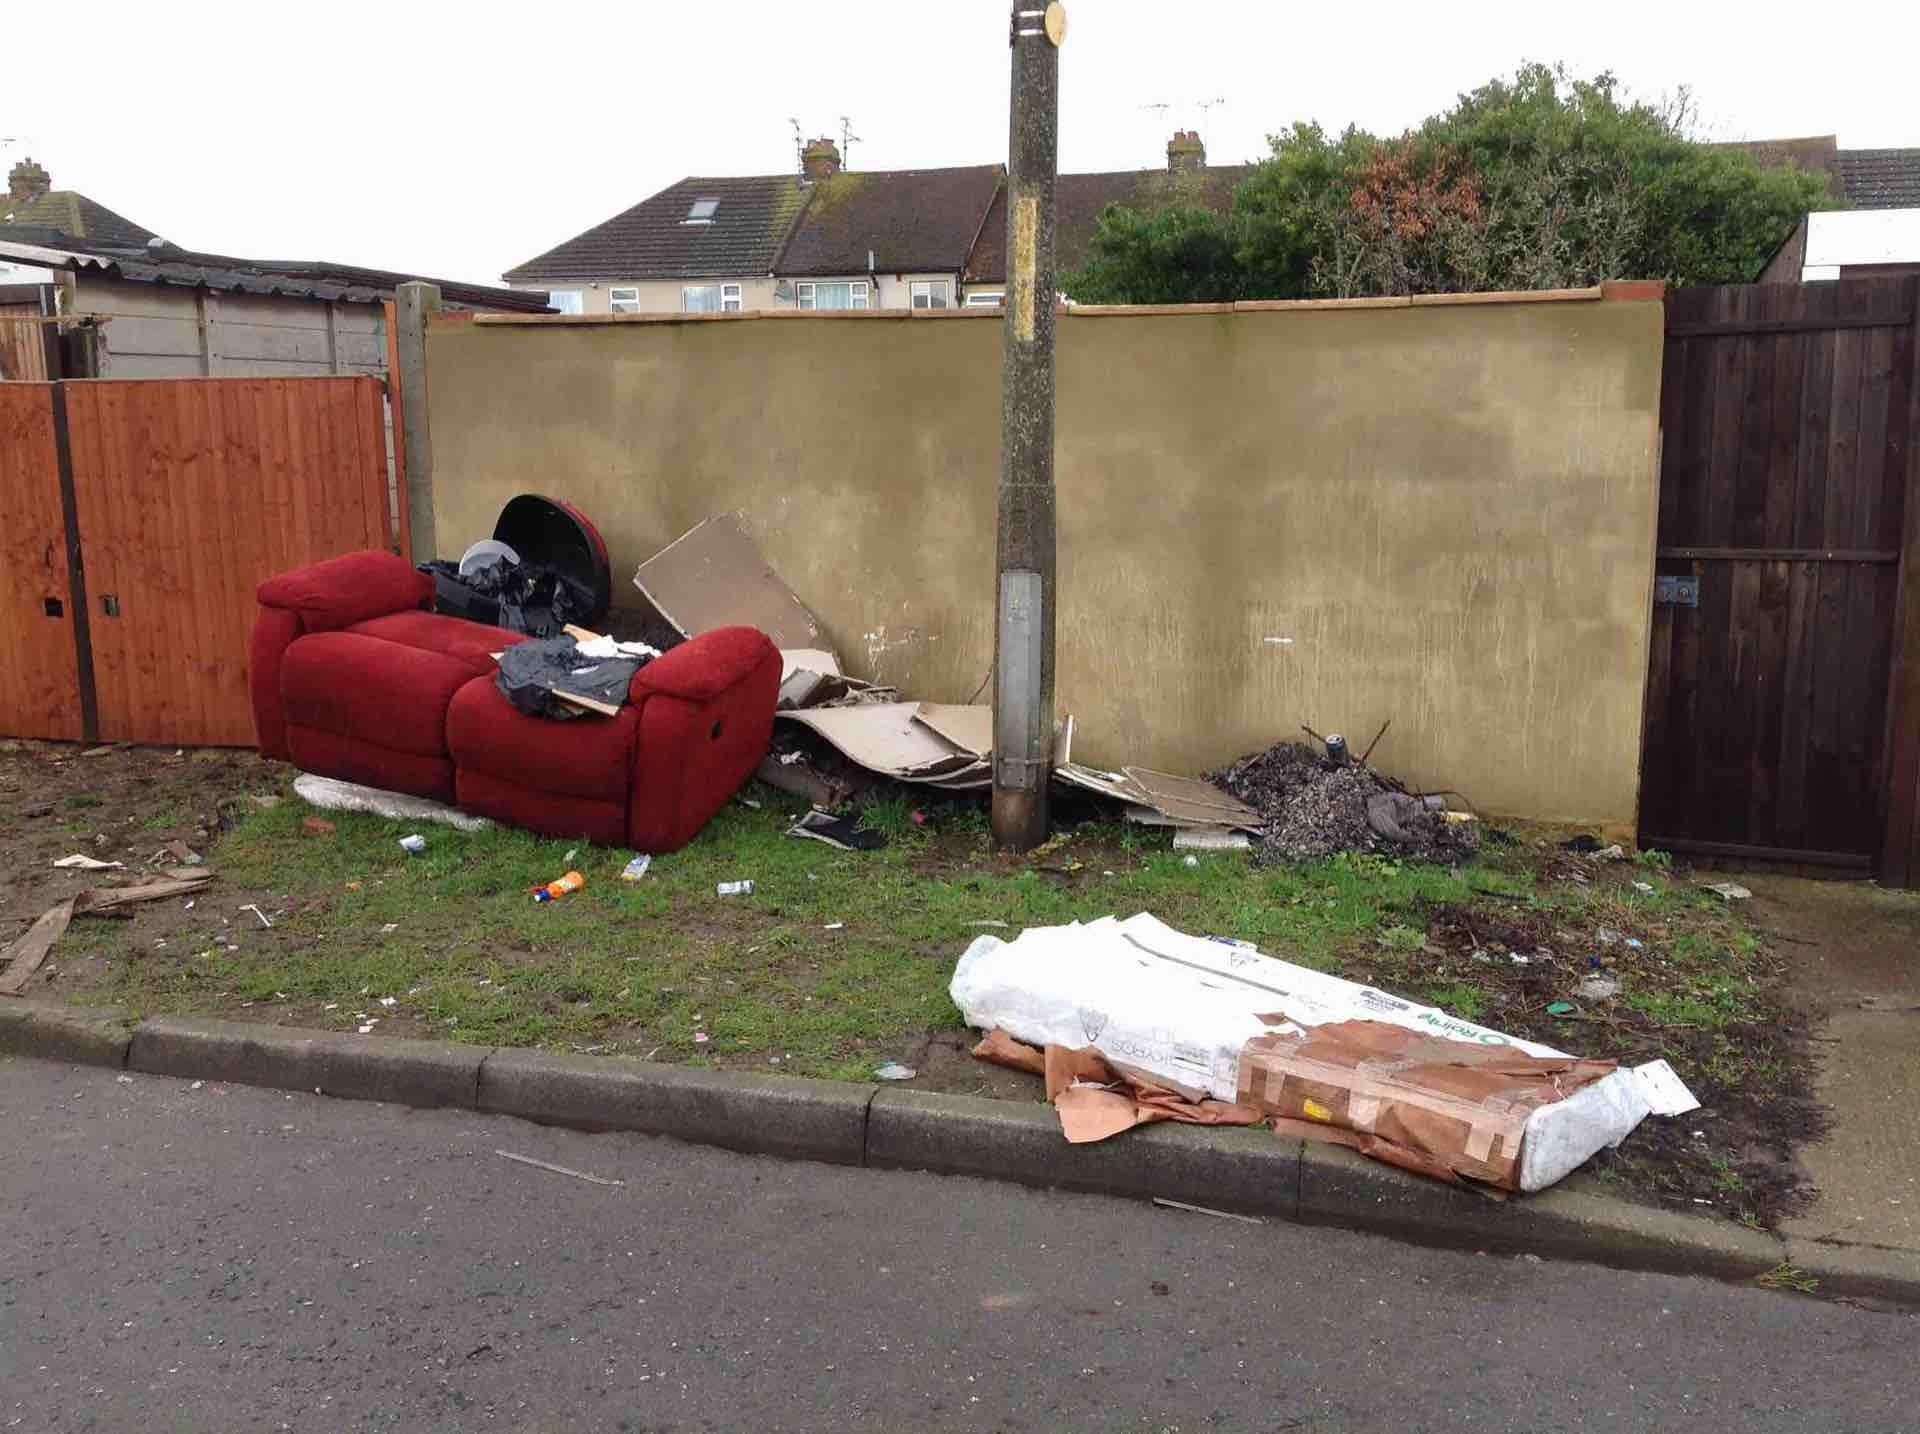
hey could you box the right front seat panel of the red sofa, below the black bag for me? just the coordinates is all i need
[447,678,639,810]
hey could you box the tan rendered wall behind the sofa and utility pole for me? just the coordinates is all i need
[428,298,1663,827]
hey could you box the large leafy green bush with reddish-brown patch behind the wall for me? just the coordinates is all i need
[1068,65,1836,303]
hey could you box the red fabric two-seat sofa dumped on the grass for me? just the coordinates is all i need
[250,553,780,852]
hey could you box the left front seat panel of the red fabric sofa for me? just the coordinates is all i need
[280,632,474,762]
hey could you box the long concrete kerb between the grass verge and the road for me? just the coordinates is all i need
[0,1000,1920,1305]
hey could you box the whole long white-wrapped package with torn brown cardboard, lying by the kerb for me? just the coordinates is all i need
[950,914,1684,1190]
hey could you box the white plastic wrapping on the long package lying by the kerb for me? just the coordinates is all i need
[950,914,1681,1190]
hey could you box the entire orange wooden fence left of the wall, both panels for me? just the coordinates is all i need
[0,378,392,747]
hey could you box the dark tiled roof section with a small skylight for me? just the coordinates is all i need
[505,175,808,284]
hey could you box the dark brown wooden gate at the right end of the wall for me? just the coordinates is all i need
[1640,278,1920,885]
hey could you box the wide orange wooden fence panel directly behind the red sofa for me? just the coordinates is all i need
[65,378,390,747]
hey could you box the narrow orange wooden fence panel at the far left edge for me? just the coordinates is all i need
[0,384,81,741]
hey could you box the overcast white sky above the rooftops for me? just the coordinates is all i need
[0,0,1920,282]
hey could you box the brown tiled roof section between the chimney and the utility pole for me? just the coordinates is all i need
[774,165,1000,276]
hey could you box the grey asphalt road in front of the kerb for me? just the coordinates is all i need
[0,1058,1920,1434]
